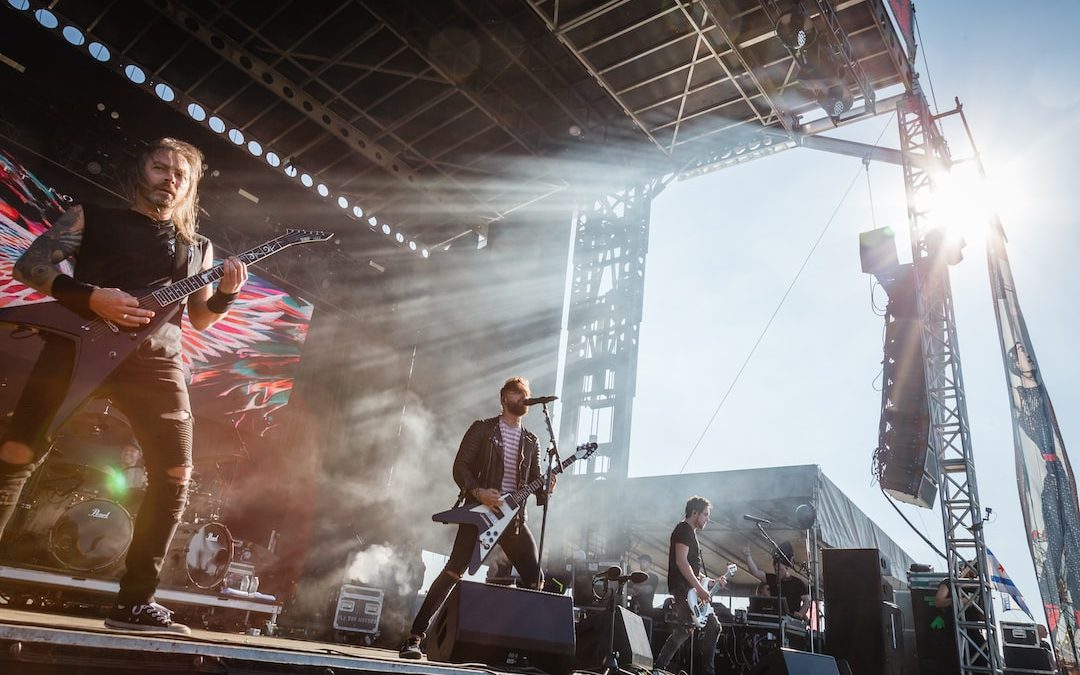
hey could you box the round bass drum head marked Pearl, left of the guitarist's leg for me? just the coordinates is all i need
[49,499,133,572]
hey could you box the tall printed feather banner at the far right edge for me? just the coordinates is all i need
[986,222,1080,670]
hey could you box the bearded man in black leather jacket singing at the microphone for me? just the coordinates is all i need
[399,377,554,659]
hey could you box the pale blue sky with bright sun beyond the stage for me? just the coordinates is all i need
[630,0,1080,622]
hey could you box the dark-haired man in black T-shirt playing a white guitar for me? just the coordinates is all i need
[656,497,728,675]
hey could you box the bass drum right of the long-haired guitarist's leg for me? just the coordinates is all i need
[164,523,232,589]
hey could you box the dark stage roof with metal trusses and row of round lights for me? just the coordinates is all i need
[0,0,913,263]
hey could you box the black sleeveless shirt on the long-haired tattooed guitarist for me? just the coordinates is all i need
[75,204,210,354]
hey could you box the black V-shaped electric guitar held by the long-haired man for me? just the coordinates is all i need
[0,229,334,440]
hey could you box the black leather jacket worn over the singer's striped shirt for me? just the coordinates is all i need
[454,417,546,505]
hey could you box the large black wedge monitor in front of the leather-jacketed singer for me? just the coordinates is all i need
[428,581,576,674]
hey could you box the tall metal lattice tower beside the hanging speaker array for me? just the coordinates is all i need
[896,90,1001,675]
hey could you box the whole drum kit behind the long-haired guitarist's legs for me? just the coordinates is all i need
[4,400,234,590]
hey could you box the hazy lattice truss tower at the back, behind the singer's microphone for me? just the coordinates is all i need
[559,176,671,478]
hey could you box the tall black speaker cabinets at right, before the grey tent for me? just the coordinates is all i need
[821,549,904,675]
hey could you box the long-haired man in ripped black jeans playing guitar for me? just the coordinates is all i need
[0,138,247,634]
